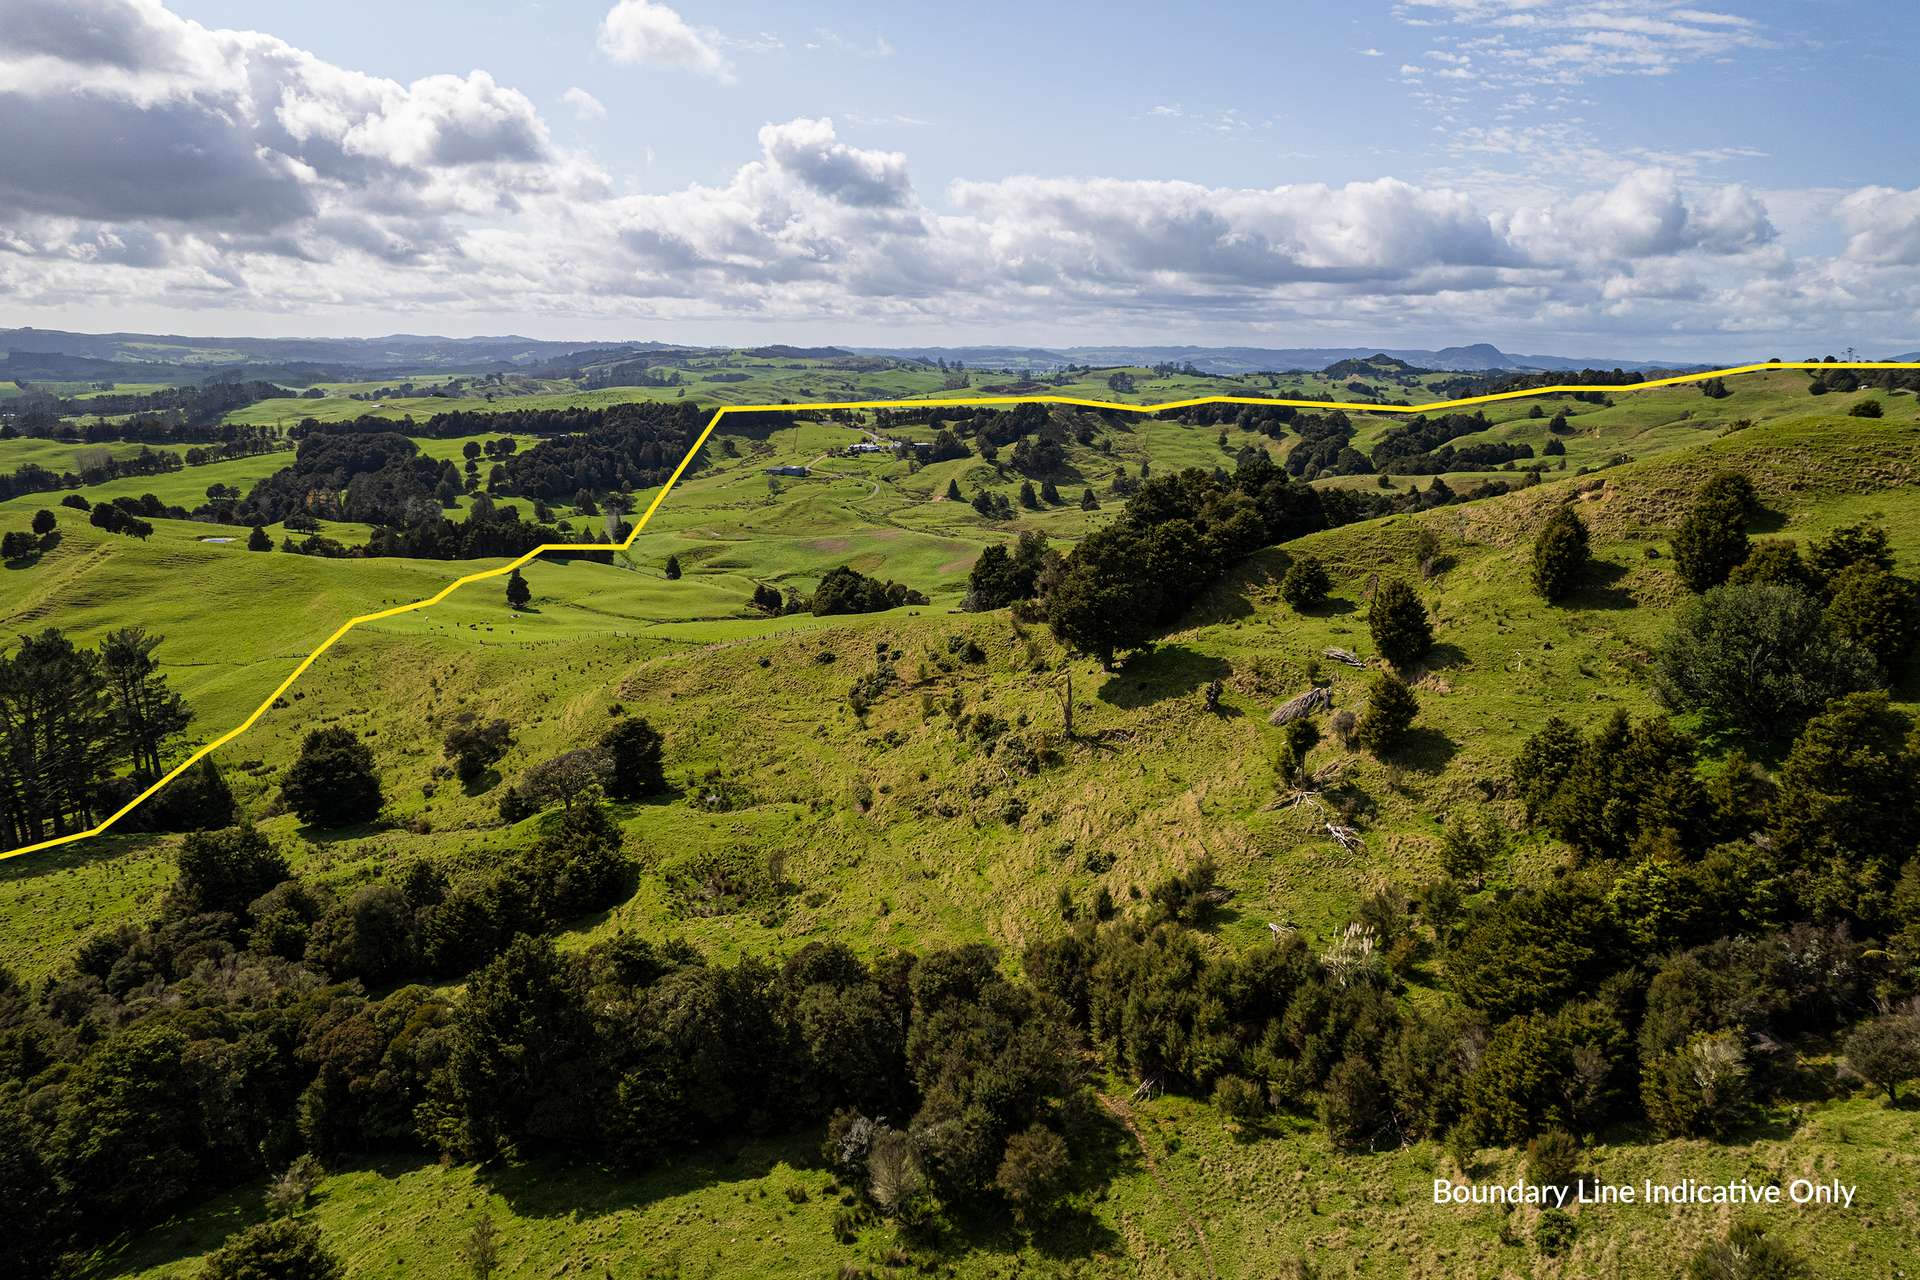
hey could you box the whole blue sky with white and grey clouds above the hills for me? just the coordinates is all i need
[0,0,1920,359]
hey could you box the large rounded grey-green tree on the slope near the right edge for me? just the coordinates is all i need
[1653,583,1874,739]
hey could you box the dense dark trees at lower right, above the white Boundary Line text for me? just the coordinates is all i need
[1025,693,1920,1167]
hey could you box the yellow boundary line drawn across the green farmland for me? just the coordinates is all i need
[0,361,1920,862]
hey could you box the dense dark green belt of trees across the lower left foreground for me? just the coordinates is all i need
[0,800,1092,1274]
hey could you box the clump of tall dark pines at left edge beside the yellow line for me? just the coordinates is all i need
[0,629,219,848]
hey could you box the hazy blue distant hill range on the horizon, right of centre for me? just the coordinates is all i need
[852,342,1713,374]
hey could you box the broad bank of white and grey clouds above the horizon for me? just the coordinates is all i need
[0,0,1920,349]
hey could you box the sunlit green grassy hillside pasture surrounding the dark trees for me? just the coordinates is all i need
[0,374,1920,1276]
